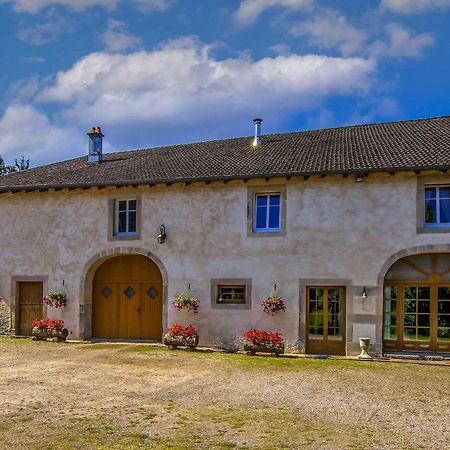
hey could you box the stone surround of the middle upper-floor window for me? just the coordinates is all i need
[247,184,287,237]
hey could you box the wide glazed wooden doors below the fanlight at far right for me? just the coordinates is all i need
[383,282,450,352]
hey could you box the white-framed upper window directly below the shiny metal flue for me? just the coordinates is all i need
[253,192,281,233]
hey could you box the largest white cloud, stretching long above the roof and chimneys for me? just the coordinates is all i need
[32,38,376,148]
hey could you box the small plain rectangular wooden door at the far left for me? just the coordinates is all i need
[17,281,44,336]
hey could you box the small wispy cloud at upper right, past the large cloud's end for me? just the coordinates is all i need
[371,23,434,58]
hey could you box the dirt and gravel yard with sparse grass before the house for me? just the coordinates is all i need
[0,338,450,449]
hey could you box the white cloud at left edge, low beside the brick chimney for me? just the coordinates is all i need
[0,104,83,166]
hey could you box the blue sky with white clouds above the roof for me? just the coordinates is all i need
[0,0,450,167]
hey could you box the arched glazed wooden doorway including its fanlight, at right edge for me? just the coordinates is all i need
[383,253,450,352]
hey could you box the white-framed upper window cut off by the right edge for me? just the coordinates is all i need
[424,185,450,227]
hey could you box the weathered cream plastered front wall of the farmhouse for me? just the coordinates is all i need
[0,173,450,352]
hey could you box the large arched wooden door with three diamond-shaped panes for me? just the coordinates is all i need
[92,255,163,340]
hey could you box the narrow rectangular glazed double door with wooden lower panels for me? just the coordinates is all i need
[306,286,345,355]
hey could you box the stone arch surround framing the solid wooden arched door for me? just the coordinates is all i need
[79,247,168,340]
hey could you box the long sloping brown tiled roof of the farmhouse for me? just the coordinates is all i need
[0,117,450,192]
